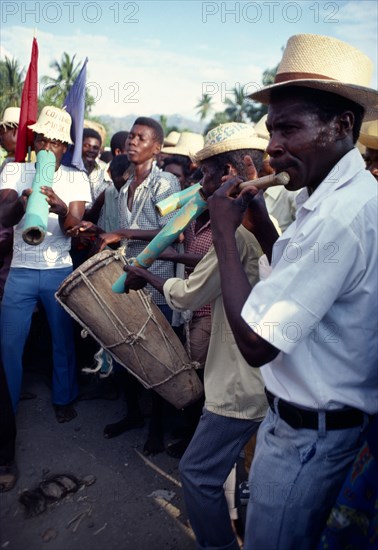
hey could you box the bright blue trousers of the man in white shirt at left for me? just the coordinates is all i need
[1,267,78,411]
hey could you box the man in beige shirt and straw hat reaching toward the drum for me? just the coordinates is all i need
[125,122,275,549]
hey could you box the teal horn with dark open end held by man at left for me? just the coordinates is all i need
[22,151,56,245]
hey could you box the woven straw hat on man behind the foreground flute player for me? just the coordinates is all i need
[193,122,268,162]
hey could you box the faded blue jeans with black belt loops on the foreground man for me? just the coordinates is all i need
[244,409,367,550]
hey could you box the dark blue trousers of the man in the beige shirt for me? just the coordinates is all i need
[179,409,260,550]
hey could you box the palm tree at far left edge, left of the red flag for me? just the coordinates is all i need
[0,57,25,113]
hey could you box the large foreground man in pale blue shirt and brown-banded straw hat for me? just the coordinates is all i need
[209,35,378,550]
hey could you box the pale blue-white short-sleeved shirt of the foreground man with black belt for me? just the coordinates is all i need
[242,149,378,414]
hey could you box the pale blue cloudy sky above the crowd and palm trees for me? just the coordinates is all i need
[0,0,378,123]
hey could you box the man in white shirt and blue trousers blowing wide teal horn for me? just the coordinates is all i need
[0,106,90,430]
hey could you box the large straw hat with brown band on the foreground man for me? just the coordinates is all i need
[249,34,378,120]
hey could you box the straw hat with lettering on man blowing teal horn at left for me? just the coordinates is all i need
[28,106,72,144]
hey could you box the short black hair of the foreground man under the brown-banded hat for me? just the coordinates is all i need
[270,86,365,143]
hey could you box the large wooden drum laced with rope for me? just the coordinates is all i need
[55,250,203,409]
